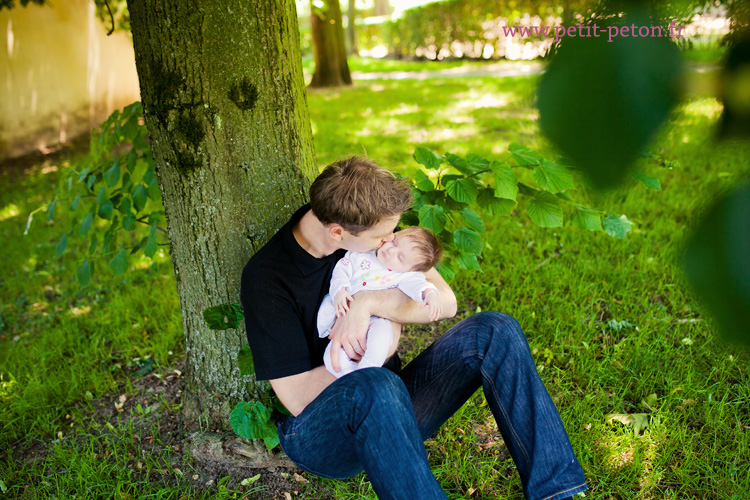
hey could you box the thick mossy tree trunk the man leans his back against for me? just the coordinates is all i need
[128,0,317,429]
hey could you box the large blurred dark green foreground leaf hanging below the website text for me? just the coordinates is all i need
[537,9,682,188]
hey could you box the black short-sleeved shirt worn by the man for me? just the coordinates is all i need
[240,204,346,380]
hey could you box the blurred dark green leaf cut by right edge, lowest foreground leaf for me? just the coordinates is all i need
[685,185,750,345]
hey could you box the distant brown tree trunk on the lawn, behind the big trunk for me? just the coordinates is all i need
[310,0,352,87]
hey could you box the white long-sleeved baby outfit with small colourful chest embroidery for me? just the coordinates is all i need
[318,250,437,378]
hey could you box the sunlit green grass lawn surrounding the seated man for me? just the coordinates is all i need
[0,67,750,500]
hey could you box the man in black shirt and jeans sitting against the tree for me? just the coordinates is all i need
[241,157,586,500]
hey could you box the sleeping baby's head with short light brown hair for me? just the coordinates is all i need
[377,226,443,272]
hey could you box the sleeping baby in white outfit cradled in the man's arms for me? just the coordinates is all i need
[318,226,443,377]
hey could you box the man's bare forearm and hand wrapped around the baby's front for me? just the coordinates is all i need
[329,268,457,370]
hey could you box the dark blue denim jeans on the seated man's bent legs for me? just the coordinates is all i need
[278,312,586,500]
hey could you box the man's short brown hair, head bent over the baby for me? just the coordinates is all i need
[310,156,412,236]
